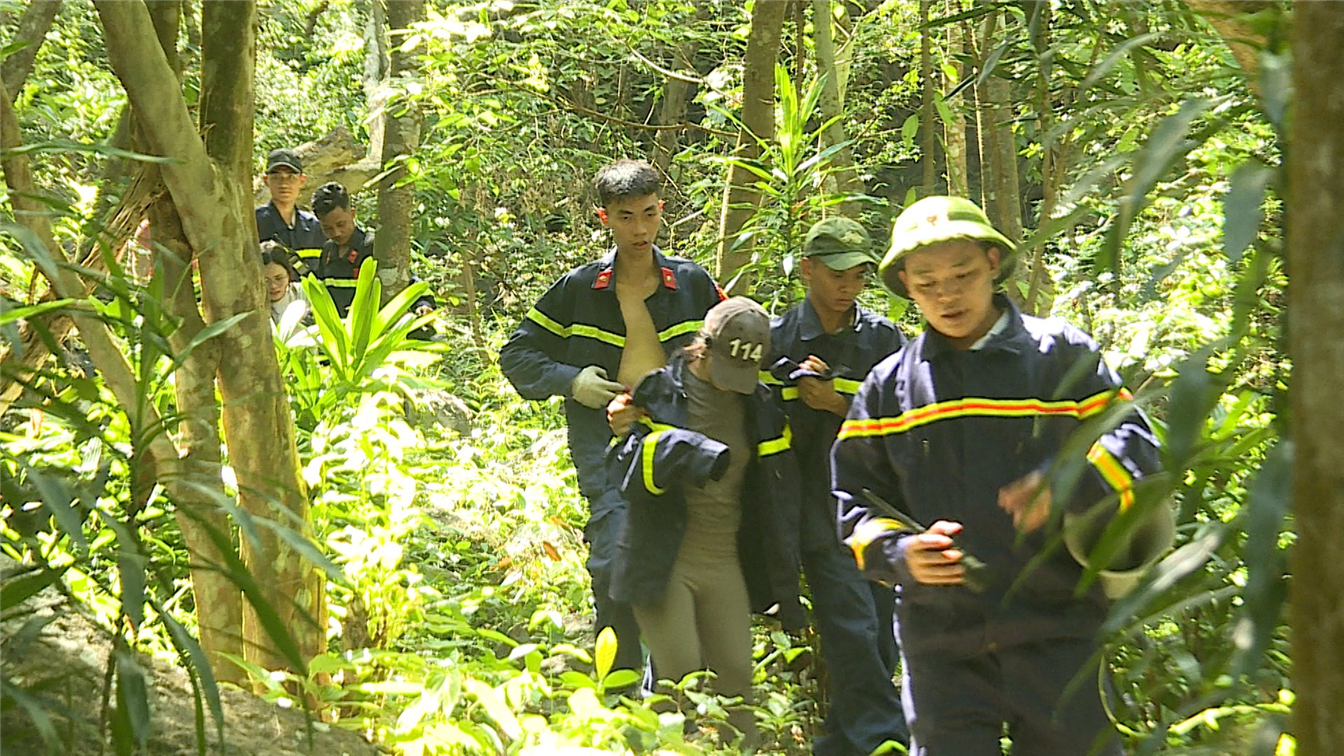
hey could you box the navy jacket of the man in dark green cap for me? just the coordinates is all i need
[761,300,906,550]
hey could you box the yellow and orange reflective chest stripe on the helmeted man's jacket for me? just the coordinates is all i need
[837,389,1133,440]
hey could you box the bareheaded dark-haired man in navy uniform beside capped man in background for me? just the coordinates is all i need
[313,182,434,317]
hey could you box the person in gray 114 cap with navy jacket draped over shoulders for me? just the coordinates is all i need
[607,297,804,745]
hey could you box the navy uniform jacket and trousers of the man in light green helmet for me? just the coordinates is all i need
[832,296,1159,756]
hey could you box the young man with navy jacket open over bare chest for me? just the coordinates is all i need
[500,160,723,669]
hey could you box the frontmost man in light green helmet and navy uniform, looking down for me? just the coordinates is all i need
[832,196,1159,756]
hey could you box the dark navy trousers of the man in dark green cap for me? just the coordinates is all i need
[802,543,910,756]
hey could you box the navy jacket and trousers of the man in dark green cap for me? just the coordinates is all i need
[761,300,910,756]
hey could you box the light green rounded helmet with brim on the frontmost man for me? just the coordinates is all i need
[878,196,1017,297]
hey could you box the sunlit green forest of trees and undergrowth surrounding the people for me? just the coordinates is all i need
[0,0,1344,756]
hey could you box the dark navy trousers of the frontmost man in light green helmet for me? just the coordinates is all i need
[903,632,1121,756]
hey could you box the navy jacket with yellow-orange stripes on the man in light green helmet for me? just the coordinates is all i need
[832,296,1159,654]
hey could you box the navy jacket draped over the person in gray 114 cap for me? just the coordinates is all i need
[607,354,804,628]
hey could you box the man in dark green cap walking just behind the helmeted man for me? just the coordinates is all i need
[762,218,910,756]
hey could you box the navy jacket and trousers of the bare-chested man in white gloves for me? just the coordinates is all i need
[500,248,724,669]
